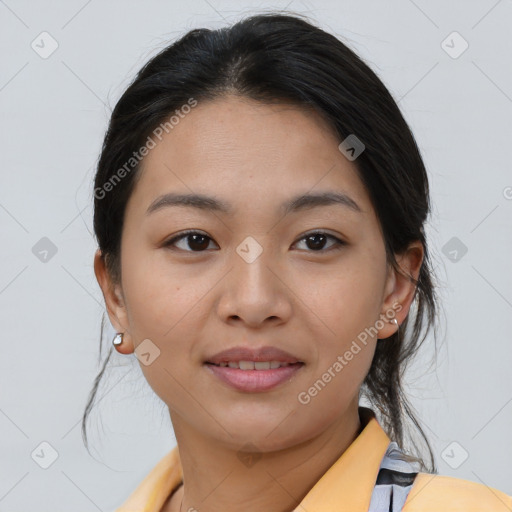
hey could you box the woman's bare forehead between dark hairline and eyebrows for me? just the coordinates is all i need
[127,96,371,220]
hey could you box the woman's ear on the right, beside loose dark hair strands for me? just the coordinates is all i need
[377,240,424,339]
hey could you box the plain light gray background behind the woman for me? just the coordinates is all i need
[0,0,512,512]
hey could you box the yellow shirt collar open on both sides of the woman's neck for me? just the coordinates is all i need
[115,406,390,512]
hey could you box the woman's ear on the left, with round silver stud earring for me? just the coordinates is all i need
[94,249,134,354]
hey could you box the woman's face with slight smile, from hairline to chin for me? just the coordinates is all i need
[97,96,421,451]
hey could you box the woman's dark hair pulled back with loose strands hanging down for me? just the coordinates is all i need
[82,12,438,473]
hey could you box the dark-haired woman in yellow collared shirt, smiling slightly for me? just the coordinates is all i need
[83,14,512,512]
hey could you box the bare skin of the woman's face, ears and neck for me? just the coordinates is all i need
[94,96,423,512]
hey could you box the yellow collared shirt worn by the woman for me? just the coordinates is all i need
[115,407,512,512]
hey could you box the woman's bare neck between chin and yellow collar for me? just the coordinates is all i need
[171,403,363,512]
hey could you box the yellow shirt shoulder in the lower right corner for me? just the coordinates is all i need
[402,472,512,512]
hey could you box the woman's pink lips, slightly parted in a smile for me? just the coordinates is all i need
[204,347,304,393]
